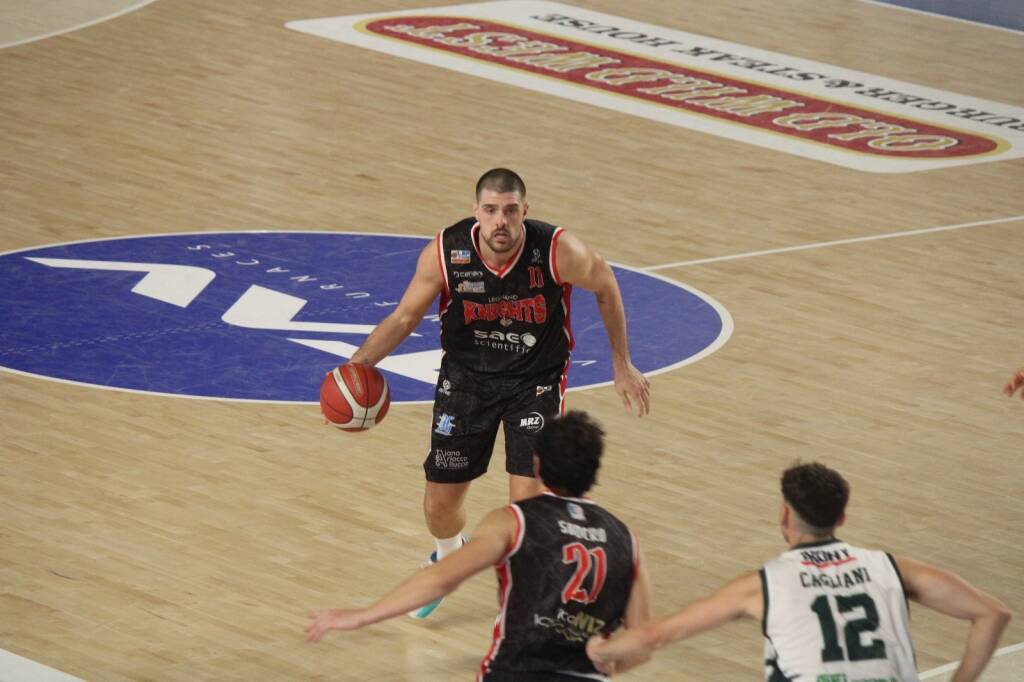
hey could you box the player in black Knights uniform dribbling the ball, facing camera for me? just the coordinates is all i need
[351,168,650,617]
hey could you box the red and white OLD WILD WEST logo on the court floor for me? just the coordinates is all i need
[288,1,1024,172]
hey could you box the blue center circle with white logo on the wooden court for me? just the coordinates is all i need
[0,231,732,403]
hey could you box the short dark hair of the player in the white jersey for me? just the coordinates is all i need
[782,462,850,535]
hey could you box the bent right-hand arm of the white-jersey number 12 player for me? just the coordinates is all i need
[896,557,1011,682]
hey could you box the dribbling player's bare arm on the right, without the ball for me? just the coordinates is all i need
[555,232,650,417]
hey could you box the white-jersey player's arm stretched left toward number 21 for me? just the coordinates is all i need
[587,573,764,674]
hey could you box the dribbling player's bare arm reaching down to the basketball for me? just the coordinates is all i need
[350,240,444,365]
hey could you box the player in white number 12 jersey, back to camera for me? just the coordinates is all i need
[587,463,1010,682]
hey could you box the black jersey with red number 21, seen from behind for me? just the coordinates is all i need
[480,493,637,680]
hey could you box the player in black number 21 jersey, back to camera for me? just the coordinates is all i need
[306,405,650,682]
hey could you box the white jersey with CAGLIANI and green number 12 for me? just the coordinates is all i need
[761,539,918,682]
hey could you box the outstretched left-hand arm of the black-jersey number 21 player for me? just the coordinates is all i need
[306,507,516,642]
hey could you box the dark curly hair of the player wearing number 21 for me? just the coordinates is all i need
[536,411,604,498]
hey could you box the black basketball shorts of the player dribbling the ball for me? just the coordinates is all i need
[423,361,562,483]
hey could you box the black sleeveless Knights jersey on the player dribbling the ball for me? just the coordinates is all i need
[437,218,572,378]
